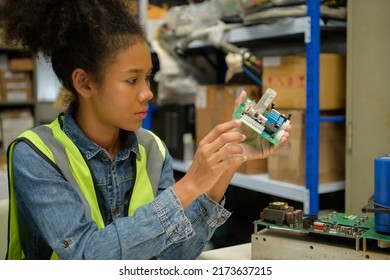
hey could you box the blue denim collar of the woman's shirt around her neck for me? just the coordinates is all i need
[62,106,141,160]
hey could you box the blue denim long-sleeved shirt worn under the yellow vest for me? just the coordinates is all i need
[13,109,231,259]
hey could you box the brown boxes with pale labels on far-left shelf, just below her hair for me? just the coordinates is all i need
[0,71,32,102]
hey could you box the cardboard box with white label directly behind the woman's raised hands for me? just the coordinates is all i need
[195,85,267,174]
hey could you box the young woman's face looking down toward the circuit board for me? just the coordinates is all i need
[91,41,153,131]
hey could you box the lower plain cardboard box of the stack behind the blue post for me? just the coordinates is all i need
[268,110,345,186]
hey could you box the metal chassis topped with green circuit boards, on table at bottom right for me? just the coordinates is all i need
[251,201,390,260]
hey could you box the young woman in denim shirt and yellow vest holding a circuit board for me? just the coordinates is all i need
[0,0,288,259]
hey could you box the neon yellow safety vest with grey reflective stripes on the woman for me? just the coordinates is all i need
[6,116,166,259]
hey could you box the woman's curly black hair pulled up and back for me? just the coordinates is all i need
[0,0,146,100]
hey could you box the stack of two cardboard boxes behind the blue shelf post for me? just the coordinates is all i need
[263,54,346,186]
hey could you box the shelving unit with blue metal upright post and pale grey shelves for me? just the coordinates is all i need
[166,0,346,214]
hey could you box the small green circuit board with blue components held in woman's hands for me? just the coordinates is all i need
[233,88,291,146]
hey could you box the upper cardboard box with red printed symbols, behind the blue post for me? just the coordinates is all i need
[263,54,346,110]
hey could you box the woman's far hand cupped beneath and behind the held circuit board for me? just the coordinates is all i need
[234,91,291,160]
